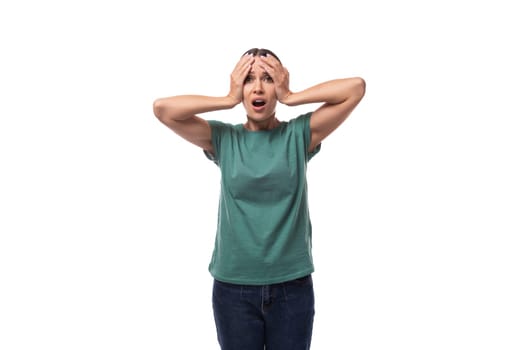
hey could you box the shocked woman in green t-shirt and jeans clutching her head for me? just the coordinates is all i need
[154,48,365,350]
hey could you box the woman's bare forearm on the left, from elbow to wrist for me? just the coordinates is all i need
[153,95,238,120]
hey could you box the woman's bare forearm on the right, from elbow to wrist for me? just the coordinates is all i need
[281,78,364,106]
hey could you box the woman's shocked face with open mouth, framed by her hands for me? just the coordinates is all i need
[243,57,277,121]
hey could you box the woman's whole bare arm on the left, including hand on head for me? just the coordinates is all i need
[153,55,254,153]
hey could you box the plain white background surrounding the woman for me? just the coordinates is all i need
[0,0,525,350]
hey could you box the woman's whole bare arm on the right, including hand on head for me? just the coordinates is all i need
[256,56,366,151]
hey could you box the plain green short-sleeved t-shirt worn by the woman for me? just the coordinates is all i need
[205,113,320,285]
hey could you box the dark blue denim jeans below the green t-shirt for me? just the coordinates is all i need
[213,275,315,350]
